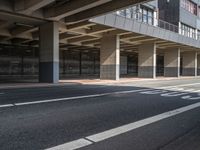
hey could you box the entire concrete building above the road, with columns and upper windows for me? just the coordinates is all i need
[0,0,200,83]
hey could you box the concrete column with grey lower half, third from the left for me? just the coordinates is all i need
[138,43,156,78]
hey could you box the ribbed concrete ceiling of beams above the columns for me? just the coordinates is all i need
[0,0,198,51]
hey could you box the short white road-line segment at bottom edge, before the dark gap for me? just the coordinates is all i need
[46,139,92,150]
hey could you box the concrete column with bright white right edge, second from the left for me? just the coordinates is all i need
[100,35,120,80]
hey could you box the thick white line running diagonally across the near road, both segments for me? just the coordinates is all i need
[46,102,200,150]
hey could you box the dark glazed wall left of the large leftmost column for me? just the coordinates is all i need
[0,44,39,76]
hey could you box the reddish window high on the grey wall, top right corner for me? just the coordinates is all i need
[181,0,197,15]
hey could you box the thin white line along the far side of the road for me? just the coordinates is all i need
[0,88,148,108]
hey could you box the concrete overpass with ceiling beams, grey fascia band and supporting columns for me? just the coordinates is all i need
[0,0,200,83]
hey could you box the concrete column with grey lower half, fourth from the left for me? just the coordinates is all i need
[164,48,180,77]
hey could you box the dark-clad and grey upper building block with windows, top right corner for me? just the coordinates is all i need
[158,0,200,39]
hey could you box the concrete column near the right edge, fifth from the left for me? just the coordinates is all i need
[182,51,197,76]
